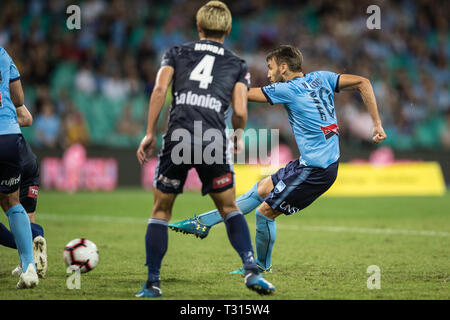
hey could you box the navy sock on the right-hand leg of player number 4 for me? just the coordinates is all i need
[224,211,258,273]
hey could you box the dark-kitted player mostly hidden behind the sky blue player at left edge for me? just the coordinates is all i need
[0,105,48,278]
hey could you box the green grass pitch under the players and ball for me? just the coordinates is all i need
[0,189,450,300]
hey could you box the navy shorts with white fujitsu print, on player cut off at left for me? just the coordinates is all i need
[0,134,25,193]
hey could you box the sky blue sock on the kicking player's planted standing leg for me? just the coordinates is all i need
[255,210,277,269]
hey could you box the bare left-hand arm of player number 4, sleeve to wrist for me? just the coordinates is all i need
[147,66,174,134]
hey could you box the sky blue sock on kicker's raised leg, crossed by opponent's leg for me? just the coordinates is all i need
[198,183,263,227]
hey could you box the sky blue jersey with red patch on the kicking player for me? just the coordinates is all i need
[261,71,340,168]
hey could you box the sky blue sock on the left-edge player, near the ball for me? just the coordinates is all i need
[6,204,36,272]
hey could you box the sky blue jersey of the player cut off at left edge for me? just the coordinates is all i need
[0,47,21,135]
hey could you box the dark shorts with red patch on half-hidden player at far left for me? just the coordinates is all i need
[20,142,39,213]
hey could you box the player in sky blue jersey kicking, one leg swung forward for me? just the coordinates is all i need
[169,45,386,273]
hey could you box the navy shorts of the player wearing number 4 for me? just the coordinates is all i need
[153,141,234,195]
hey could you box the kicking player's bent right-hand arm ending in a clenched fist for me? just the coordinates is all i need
[338,74,386,143]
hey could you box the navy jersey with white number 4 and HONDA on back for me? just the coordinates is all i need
[161,40,250,140]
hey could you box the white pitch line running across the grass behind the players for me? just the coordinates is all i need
[37,213,450,237]
